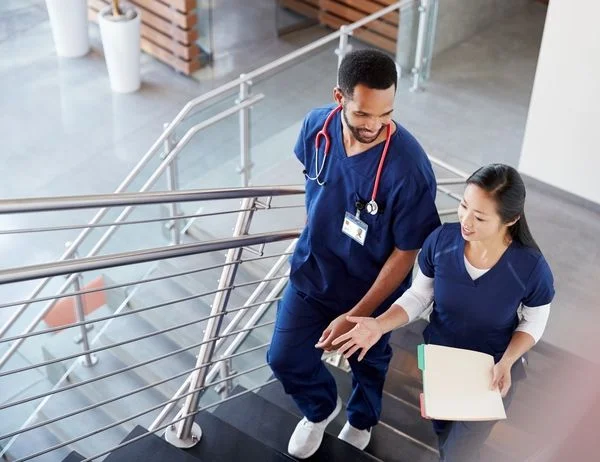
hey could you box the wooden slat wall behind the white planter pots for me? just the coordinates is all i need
[88,0,200,75]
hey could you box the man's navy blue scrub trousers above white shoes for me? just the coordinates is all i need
[267,284,392,430]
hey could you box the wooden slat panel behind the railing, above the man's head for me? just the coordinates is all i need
[279,0,400,53]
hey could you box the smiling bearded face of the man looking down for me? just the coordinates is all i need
[334,84,396,144]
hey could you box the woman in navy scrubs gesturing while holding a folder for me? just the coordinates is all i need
[333,164,554,462]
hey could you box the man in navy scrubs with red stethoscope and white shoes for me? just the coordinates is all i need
[267,50,440,459]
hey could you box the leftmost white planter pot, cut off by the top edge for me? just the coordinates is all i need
[46,0,90,58]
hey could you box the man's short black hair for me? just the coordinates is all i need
[338,49,398,98]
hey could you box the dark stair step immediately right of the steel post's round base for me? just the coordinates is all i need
[187,412,293,462]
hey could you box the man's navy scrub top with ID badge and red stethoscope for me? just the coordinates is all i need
[290,106,440,312]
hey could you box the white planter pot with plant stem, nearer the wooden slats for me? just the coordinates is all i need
[98,5,141,93]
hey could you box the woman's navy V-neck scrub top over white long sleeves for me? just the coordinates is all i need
[418,223,554,362]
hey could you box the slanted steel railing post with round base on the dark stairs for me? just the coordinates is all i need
[165,198,256,448]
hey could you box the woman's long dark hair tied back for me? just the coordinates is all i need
[467,164,540,251]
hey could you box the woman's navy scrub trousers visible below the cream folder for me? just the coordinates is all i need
[432,382,516,462]
